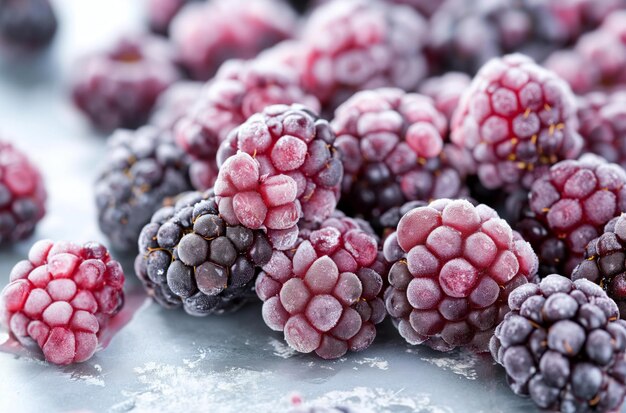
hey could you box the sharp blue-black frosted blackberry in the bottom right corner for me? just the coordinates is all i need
[490,274,626,413]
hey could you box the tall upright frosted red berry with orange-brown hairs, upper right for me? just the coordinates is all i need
[451,54,582,190]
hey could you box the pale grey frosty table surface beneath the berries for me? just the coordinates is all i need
[0,0,576,413]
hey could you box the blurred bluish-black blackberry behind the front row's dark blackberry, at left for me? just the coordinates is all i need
[95,126,191,251]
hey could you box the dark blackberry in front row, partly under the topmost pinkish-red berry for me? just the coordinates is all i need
[135,191,272,316]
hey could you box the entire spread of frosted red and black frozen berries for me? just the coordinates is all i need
[6,0,626,413]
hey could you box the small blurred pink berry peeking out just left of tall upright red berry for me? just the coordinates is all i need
[418,72,472,121]
